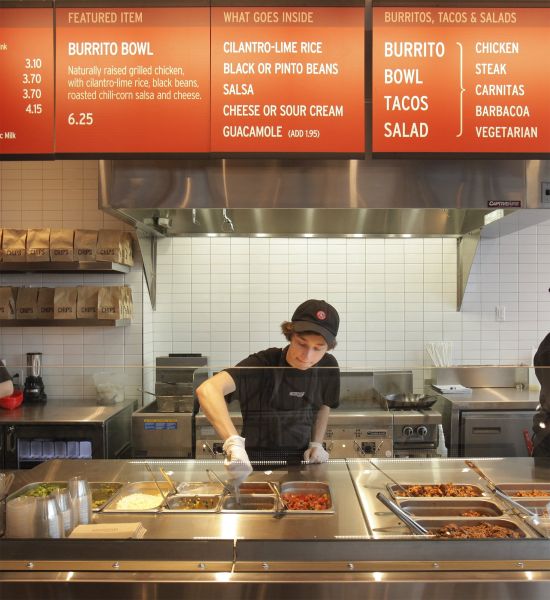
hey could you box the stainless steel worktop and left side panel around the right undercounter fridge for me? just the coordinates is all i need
[434,387,539,457]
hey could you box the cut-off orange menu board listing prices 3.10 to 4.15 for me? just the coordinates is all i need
[0,7,54,156]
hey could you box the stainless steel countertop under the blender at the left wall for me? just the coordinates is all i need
[0,399,133,425]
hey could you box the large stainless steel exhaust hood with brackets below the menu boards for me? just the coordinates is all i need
[100,154,548,307]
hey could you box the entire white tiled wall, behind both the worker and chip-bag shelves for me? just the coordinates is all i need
[0,161,550,399]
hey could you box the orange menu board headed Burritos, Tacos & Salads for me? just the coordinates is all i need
[372,6,550,154]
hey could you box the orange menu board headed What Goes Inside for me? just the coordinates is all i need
[211,5,365,155]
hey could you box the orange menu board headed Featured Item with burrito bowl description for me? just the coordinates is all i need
[55,6,210,154]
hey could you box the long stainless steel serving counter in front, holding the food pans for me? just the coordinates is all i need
[0,459,550,600]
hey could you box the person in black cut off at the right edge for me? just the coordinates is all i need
[533,333,550,458]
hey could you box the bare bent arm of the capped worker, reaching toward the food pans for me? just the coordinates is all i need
[197,371,242,441]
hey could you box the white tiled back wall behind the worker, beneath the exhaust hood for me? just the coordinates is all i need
[152,210,550,369]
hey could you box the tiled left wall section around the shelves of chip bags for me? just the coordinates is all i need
[0,160,144,402]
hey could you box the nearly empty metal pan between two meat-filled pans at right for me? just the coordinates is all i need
[399,498,503,518]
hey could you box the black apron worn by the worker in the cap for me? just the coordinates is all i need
[244,352,318,467]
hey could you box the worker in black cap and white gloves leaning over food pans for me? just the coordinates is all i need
[197,300,340,481]
